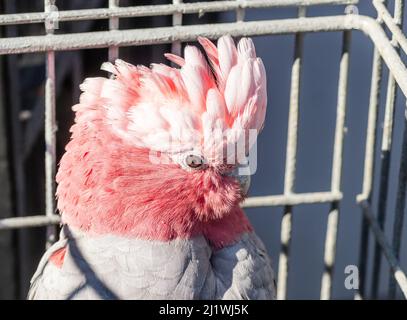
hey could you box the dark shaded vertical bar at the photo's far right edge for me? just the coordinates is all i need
[389,105,407,299]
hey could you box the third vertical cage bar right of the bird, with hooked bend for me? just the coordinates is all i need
[355,49,382,299]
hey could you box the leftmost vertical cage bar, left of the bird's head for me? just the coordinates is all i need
[44,0,56,247]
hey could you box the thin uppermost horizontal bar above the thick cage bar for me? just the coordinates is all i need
[0,0,359,25]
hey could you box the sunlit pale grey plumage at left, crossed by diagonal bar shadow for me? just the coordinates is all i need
[30,228,215,299]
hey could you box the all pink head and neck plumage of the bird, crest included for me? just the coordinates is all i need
[57,36,267,246]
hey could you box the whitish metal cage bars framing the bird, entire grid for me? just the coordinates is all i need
[0,0,407,299]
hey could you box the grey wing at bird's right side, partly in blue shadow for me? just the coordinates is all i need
[211,233,276,300]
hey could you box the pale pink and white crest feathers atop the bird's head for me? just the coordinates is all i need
[77,36,267,163]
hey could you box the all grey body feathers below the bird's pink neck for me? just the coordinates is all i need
[29,227,275,299]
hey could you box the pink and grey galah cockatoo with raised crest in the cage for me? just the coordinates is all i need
[29,36,275,299]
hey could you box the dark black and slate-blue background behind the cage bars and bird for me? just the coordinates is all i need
[0,0,407,299]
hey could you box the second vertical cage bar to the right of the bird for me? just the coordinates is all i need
[321,31,351,300]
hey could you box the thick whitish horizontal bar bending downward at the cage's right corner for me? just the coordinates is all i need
[0,15,407,96]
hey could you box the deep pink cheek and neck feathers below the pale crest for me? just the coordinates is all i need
[57,134,250,246]
